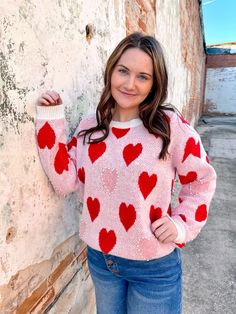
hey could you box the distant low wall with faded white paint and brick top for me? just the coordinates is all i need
[204,54,236,114]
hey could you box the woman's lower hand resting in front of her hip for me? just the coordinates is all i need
[151,216,178,243]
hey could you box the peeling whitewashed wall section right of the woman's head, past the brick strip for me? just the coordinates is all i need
[156,0,205,125]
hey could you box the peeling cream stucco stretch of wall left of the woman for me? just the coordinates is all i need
[0,0,126,314]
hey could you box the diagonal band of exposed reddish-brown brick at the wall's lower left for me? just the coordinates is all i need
[0,234,88,314]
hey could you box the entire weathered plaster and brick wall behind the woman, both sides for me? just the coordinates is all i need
[0,0,204,314]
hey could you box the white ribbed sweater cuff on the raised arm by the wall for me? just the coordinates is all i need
[36,105,65,120]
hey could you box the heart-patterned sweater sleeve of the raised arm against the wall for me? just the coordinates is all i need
[36,105,84,196]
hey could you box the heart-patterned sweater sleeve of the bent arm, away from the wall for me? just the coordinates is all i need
[170,114,216,247]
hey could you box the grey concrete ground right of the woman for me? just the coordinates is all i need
[182,116,236,314]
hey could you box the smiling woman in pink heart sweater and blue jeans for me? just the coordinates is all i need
[36,33,216,314]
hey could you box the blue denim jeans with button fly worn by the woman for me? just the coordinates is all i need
[87,246,182,314]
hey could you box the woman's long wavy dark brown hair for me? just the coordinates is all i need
[78,32,174,160]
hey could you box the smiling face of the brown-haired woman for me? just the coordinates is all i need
[111,48,153,116]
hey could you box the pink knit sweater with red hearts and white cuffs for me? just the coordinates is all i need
[36,105,216,260]
